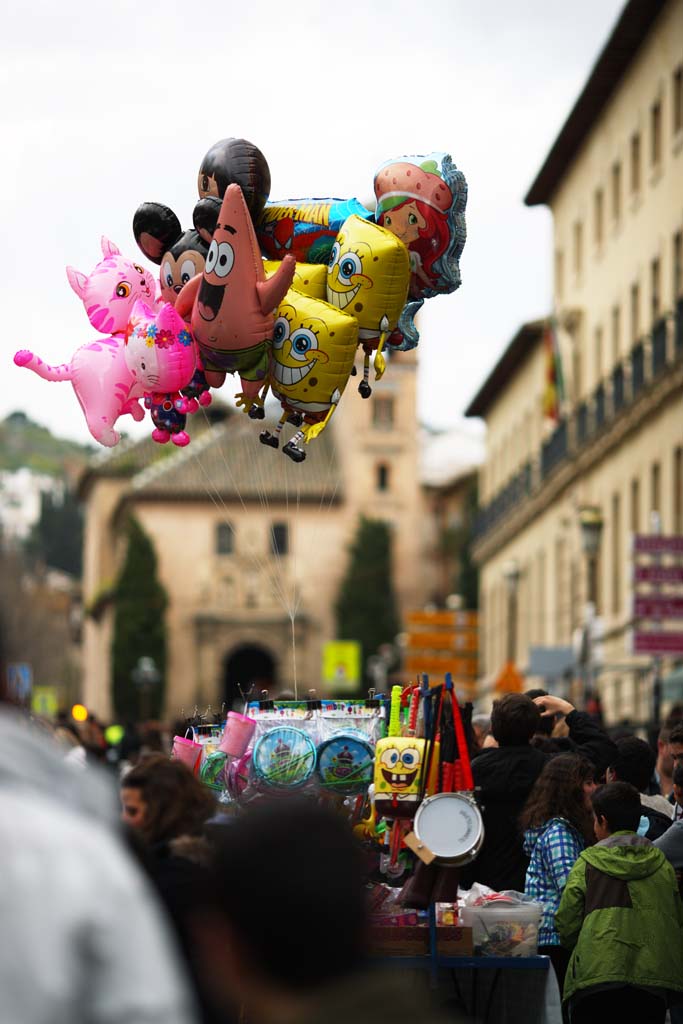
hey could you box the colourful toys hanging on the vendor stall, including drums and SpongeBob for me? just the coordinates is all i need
[173,676,524,953]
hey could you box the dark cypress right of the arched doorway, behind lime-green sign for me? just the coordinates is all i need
[335,516,400,684]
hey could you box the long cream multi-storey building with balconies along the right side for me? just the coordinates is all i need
[467,0,683,722]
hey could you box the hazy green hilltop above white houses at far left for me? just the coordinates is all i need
[0,412,95,478]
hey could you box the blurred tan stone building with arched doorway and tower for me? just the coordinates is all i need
[81,353,432,718]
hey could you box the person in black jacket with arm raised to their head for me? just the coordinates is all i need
[461,693,616,892]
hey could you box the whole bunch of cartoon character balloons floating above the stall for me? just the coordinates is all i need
[14,138,467,462]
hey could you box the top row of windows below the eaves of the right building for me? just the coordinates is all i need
[555,65,683,290]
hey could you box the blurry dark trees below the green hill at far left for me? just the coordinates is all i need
[27,486,83,577]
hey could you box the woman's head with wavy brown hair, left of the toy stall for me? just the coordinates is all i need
[121,754,214,843]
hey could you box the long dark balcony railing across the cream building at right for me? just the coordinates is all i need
[475,297,683,538]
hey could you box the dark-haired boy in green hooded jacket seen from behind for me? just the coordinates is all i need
[555,782,683,1024]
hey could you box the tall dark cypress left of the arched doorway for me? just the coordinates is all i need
[112,519,168,719]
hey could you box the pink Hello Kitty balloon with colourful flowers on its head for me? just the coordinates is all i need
[124,301,197,447]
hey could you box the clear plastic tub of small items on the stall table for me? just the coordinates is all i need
[460,900,543,956]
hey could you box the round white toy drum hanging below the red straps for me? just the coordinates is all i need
[414,793,483,867]
